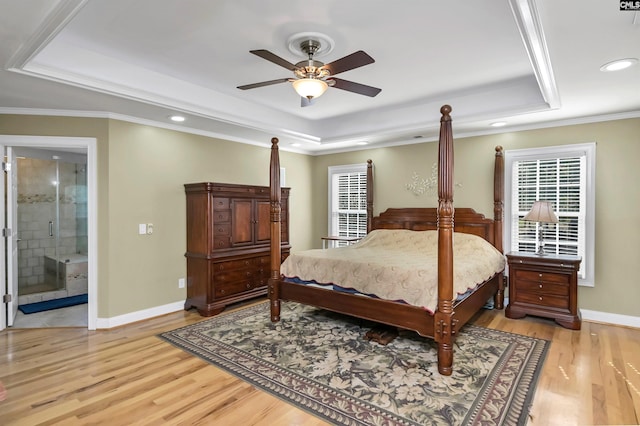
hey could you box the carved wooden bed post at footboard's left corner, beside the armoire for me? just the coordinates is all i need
[269,138,282,322]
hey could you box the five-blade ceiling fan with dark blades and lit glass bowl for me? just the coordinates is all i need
[238,39,382,107]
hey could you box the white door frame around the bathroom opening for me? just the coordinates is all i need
[0,135,98,330]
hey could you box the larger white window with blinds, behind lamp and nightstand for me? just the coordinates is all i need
[505,143,596,286]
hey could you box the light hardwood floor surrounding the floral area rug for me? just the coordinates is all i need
[0,300,640,426]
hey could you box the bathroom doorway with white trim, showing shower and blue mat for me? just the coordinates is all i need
[0,136,97,330]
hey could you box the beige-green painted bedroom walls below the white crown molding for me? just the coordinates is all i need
[0,115,640,318]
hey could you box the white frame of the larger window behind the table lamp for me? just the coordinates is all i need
[504,142,596,287]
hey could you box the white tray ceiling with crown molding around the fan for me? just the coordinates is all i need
[0,0,640,154]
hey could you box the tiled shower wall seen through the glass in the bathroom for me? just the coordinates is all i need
[18,158,87,294]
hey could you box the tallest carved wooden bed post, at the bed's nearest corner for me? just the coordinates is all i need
[434,105,455,376]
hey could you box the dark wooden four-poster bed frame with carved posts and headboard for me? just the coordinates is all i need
[268,105,504,375]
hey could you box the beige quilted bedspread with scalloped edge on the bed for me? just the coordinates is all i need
[281,229,505,312]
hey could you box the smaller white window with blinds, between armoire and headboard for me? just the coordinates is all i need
[329,163,367,245]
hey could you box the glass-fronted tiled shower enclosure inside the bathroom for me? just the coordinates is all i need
[15,148,88,304]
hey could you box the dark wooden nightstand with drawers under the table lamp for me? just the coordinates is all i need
[505,252,582,330]
